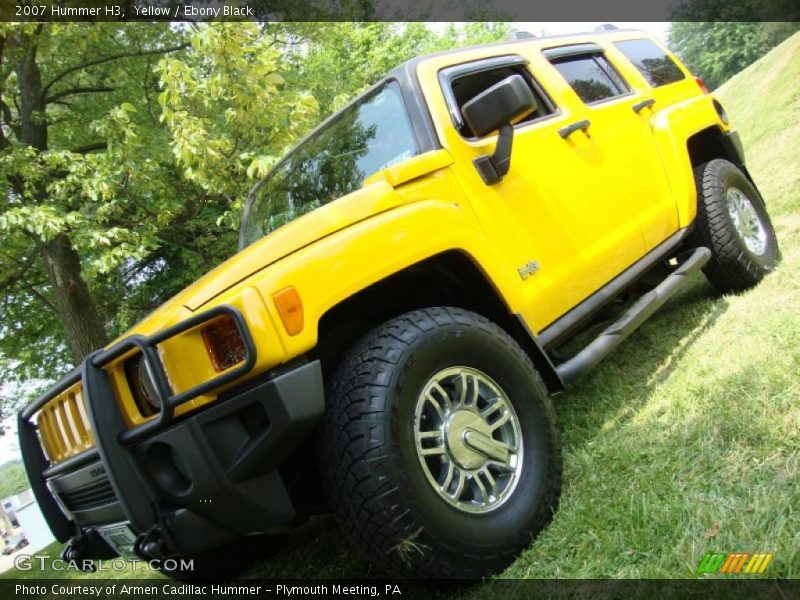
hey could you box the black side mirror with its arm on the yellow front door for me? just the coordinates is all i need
[461,75,536,185]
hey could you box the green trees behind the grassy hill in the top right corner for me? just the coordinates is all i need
[669,19,800,89]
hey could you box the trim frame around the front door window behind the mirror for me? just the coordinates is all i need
[439,54,561,142]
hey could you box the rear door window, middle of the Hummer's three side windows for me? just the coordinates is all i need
[550,53,630,104]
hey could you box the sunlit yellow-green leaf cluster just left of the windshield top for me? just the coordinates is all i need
[156,23,317,226]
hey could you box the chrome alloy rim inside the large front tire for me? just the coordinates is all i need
[414,367,522,513]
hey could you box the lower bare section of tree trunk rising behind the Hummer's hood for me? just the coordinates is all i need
[42,234,108,364]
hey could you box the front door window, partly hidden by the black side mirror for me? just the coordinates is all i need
[442,64,556,138]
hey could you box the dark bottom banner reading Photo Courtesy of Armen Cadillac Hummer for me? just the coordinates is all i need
[0,577,800,600]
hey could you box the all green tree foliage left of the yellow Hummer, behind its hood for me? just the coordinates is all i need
[0,21,509,411]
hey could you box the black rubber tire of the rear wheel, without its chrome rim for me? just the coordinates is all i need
[692,158,780,293]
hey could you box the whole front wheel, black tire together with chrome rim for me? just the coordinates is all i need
[322,308,561,578]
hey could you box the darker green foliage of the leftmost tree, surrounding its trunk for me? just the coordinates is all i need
[0,24,205,399]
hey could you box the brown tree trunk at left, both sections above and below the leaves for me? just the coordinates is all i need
[16,29,108,364]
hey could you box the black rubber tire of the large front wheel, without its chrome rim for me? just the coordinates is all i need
[321,308,561,579]
